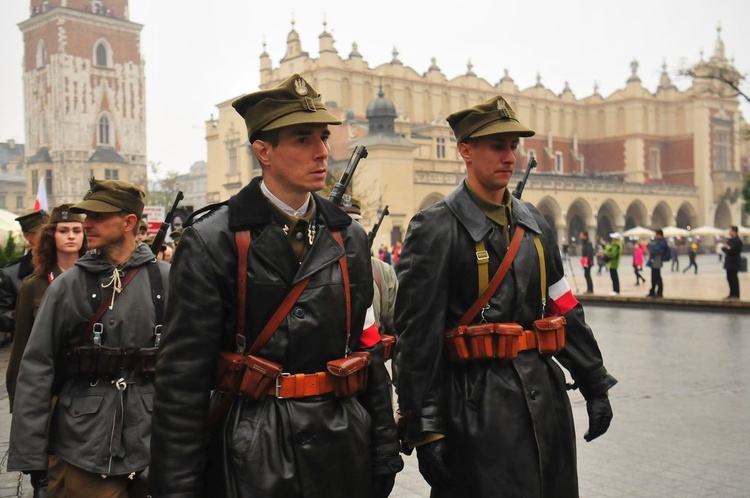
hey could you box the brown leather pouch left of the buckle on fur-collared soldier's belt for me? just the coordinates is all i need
[216,351,283,400]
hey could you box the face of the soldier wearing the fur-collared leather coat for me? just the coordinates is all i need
[253,124,331,203]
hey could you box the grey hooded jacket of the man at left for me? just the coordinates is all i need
[8,244,169,475]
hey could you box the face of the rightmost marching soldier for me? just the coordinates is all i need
[458,133,518,198]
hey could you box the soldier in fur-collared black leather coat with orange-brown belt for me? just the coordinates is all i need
[149,75,403,498]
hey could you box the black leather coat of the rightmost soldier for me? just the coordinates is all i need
[396,184,616,498]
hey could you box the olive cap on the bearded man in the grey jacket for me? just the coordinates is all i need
[70,177,146,218]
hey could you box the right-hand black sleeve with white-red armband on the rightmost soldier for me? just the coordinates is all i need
[545,224,617,398]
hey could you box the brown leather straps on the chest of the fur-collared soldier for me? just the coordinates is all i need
[235,230,351,354]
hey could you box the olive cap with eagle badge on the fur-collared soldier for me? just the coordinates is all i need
[232,74,341,143]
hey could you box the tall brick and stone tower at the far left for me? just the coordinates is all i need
[19,0,146,208]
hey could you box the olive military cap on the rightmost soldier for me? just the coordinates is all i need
[446,95,536,143]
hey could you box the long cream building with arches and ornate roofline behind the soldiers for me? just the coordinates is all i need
[206,25,748,249]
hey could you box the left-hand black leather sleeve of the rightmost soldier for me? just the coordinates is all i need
[395,212,451,443]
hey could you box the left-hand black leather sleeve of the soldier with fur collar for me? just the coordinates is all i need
[149,228,229,497]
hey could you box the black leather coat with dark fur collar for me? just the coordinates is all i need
[149,178,401,498]
